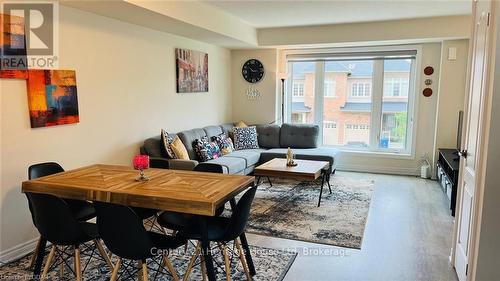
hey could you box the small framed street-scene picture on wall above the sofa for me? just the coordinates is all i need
[175,48,208,93]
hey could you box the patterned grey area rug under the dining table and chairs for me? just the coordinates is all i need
[0,240,297,281]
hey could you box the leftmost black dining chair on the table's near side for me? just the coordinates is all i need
[26,192,113,280]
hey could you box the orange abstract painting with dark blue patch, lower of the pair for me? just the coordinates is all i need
[27,70,79,128]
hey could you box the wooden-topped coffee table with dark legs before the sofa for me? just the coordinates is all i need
[253,158,332,207]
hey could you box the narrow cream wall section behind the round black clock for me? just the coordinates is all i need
[231,49,280,124]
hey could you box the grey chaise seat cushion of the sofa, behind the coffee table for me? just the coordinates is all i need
[260,147,340,170]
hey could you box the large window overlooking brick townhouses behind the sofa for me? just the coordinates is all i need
[287,47,417,154]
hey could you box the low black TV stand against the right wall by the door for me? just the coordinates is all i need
[436,148,460,216]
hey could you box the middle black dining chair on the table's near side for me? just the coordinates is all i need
[94,201,186,281]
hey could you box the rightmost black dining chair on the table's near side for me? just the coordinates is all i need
[177,187,257,280]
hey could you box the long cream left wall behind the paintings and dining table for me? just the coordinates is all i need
[0,6,232,257]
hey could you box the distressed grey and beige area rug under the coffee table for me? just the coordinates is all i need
[246,173,374,249]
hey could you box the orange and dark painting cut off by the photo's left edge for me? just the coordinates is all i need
[0,14,28,79]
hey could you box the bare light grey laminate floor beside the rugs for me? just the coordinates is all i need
[248,172,457,281]
